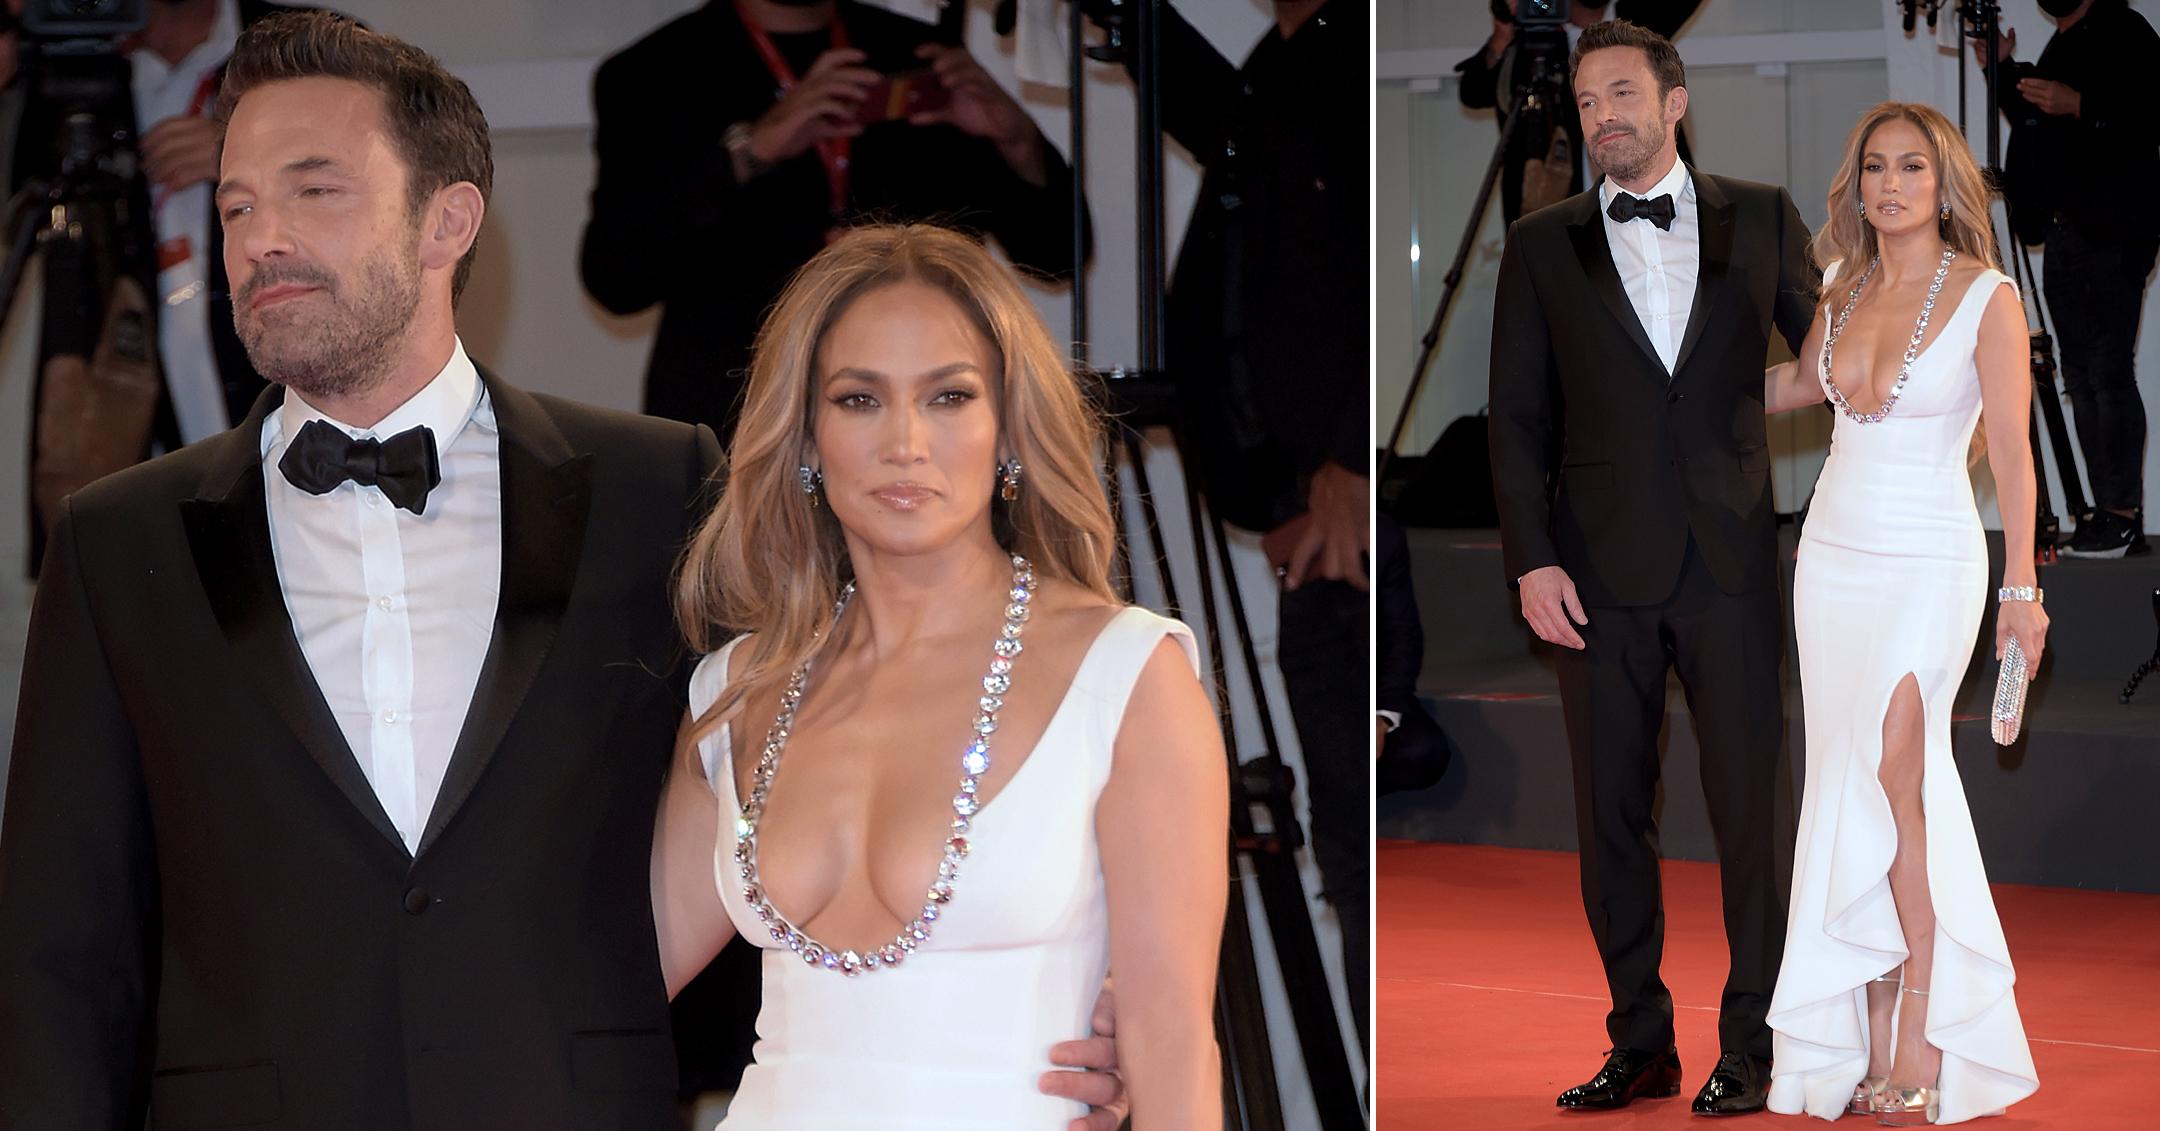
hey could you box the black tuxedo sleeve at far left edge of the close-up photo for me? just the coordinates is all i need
[0,507,157,1129]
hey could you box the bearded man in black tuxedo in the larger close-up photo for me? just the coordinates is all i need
[0,13,1108,1131]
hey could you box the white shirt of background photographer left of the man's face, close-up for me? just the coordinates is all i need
[127,0,240,445]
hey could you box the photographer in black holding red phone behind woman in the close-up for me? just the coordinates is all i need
[579,0,1076,446]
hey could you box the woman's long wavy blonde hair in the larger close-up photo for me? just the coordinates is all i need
[676,224,1117,742]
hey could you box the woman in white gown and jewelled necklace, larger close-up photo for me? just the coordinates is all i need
[652,227,1229,1131]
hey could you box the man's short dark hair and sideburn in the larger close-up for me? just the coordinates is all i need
[214,11,495,302]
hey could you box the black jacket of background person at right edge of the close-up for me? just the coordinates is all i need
[1162,0,1372,531]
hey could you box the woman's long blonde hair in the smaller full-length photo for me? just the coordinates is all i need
[1812,101,2002,294]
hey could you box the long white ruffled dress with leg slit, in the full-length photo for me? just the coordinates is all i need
[1769,270,2039,1122]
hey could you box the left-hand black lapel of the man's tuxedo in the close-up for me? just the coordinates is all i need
[179,386,404,853]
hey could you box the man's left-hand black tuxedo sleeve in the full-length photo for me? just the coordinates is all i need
[1486,224,1560,587]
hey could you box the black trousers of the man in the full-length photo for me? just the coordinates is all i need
[1557,542,1793,1060]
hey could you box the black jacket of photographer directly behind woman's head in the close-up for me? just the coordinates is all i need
[579,0,1074,438]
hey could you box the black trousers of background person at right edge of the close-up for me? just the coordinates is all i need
[1277,581,1372,1047]
